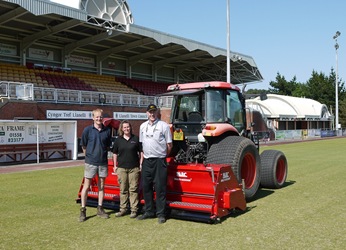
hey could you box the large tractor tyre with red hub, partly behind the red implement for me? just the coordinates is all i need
[206,136,260,199]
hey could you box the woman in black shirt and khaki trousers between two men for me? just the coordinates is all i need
[113,120,143,218]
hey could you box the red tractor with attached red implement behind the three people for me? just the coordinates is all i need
[77,82,288,222]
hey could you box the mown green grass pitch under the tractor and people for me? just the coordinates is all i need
[0,138,346,250]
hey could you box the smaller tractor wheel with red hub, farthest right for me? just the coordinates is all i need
[261,150,287,188]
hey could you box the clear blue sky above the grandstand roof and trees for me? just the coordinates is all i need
[50,0,346,89]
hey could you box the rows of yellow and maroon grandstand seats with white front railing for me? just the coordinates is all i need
[0,62,173,106]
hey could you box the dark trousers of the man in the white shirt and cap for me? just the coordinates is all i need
[141,158,167,217]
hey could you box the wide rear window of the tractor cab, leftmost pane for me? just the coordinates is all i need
[174,92,205,123]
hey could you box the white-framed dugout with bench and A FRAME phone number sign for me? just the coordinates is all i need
[0,120,77,165]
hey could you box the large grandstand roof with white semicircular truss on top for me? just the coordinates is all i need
[0,0,263,84]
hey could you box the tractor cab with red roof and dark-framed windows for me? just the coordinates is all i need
[164,82,246,163]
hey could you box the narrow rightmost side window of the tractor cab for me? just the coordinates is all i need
[226,91,244,132]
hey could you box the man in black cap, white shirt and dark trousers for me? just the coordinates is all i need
[137,104,172,224]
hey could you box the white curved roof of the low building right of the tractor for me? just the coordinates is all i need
[246,94,332,120]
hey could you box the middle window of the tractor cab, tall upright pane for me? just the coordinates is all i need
[206,90,225,122]
